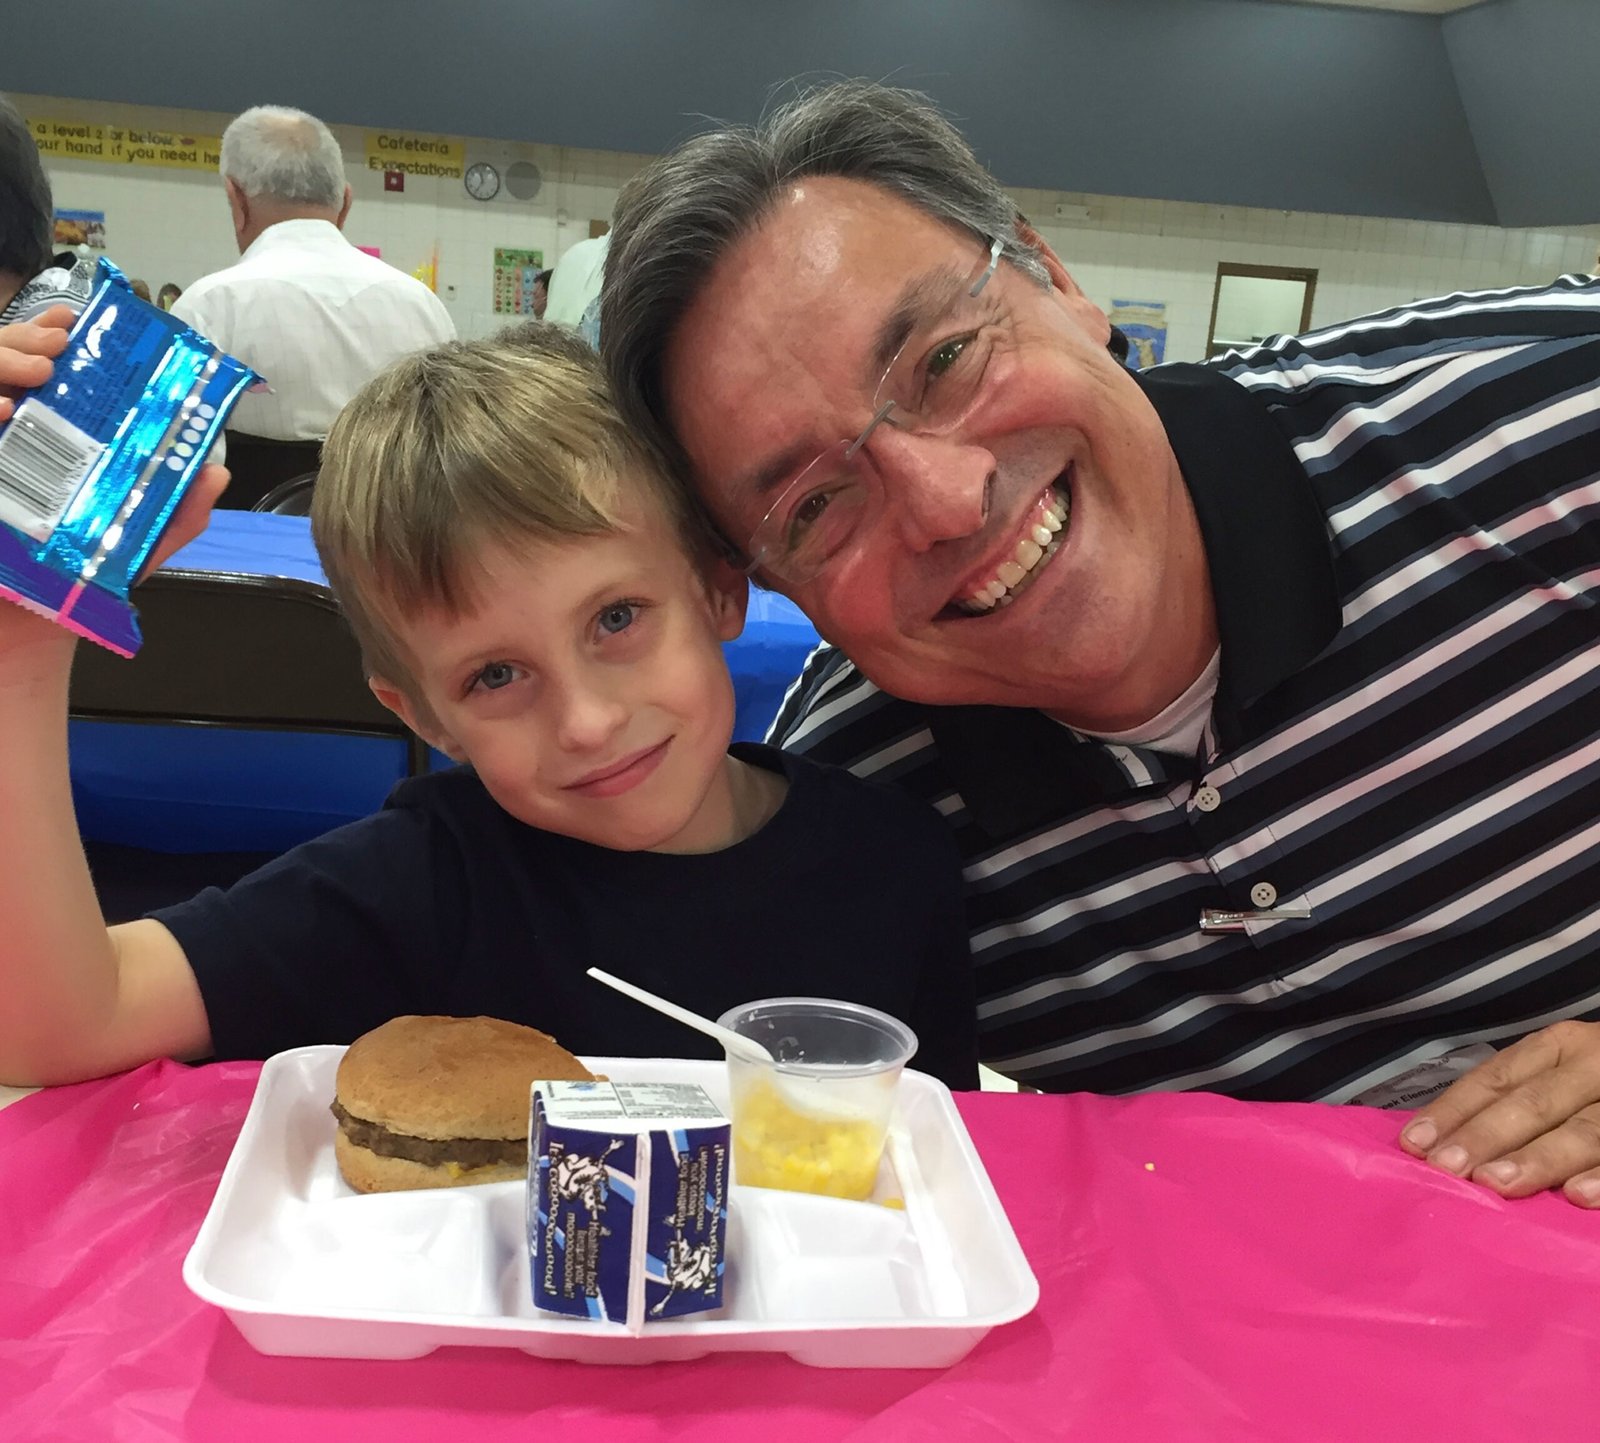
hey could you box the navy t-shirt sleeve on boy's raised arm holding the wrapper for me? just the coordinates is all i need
[152,806,464,1057]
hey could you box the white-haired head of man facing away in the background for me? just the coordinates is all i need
[221,106,350,253]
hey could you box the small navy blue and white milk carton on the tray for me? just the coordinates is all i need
[526,1081,730,1333]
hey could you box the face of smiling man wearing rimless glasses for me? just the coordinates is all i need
[662,186,1216,728]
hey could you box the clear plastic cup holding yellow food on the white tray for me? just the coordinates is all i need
[717,997,917,1198]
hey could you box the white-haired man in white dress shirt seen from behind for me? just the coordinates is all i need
[173,106,456,506]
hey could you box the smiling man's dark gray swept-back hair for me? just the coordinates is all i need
[600,80,1048,478]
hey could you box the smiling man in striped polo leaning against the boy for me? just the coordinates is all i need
[602,82,1600,1206]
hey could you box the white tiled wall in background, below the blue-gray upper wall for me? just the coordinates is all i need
[11,91,1600,360]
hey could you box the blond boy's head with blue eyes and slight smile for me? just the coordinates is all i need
[312,322,746,851]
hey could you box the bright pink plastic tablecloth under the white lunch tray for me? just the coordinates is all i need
[0,1064,1600,1443]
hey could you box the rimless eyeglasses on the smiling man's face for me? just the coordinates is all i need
[732,238,1005,586]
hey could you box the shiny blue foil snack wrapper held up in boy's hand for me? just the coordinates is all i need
[0,261,259,656]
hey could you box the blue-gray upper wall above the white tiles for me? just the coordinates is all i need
[12,0,1600,226]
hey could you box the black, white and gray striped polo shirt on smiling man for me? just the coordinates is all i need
[774,277,1600,1101]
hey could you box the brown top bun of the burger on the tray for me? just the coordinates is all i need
[334,1017,594,1139]
